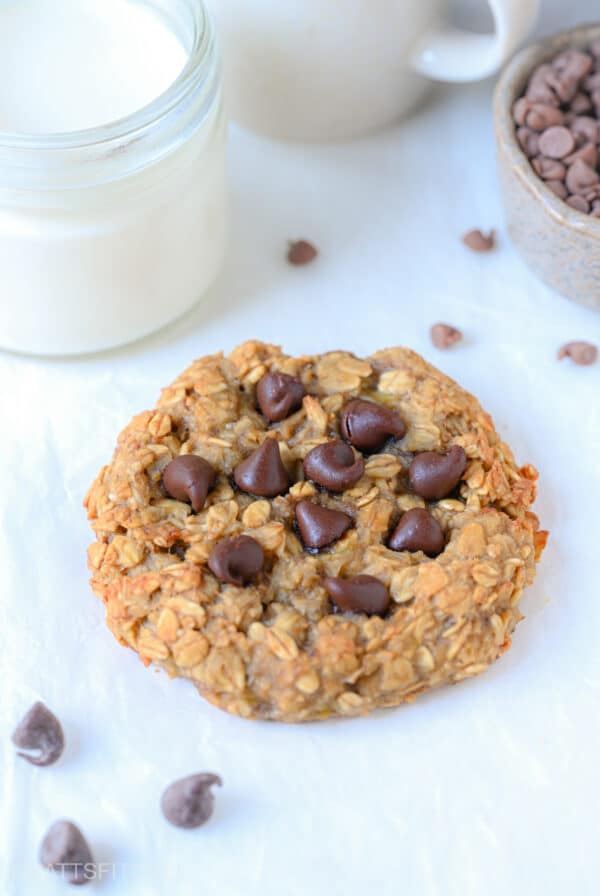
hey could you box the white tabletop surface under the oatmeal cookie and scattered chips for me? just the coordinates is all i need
[0,0,600,896]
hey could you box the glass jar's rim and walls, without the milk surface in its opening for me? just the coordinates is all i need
[0,0,227,355]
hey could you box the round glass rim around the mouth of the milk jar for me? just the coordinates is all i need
[0,0,213,151]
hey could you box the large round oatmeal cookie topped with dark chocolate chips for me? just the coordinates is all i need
[86,342,545,721]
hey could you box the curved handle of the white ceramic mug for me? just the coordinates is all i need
[412,0,540,82]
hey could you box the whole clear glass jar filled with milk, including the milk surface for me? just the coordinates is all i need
[0,0,227,354]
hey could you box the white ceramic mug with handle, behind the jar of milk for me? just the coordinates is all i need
[206,0,539,140]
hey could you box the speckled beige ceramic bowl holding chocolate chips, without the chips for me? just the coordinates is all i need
[494,25,600,310]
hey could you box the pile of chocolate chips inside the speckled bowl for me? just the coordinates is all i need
[513,40,600,218]
